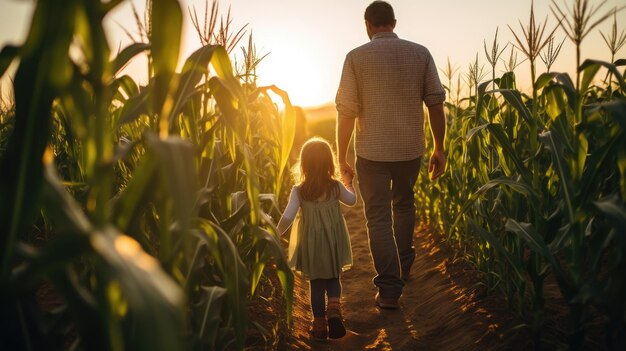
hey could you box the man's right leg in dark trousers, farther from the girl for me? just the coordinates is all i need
[391,158,421,278]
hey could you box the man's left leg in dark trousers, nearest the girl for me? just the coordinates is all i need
[356,157,404,298]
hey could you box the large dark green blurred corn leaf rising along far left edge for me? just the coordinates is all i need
[0,1,77,280]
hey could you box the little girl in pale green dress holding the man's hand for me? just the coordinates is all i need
[277,138,356,340]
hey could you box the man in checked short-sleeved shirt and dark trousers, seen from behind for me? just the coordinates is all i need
[335,1,446,309]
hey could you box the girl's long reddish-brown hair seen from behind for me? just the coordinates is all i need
[299,137,339,201]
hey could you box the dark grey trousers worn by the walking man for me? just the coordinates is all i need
[356,157,421,298]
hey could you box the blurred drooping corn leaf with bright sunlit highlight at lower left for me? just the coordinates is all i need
[44,163,183,350]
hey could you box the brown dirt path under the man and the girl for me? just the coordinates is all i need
[286,200,525,350]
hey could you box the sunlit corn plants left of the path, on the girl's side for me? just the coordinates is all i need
[0,0,295,350]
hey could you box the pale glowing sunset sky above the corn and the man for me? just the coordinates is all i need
[0,0,626,107]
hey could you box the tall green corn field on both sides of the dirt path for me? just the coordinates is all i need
[0,0,626,350]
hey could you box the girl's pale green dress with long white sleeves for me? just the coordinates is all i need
[278,182,356,280]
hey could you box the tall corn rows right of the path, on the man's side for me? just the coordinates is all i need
[416,0,626,350]
